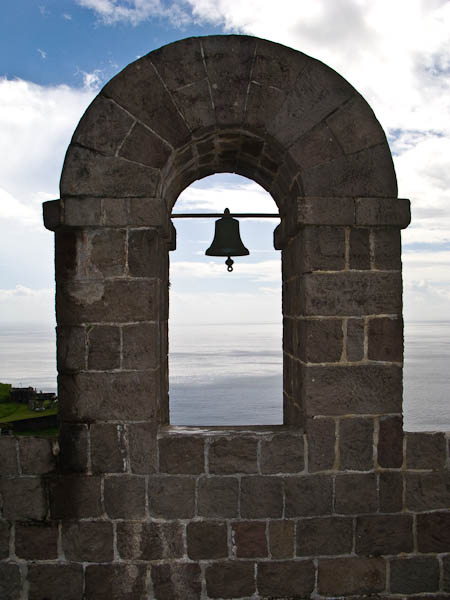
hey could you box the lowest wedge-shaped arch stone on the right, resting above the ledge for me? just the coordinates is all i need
[302,143,397,197]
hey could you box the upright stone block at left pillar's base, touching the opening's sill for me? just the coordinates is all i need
[127,423,157,474]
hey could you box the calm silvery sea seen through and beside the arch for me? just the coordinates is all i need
[0,321,450,431]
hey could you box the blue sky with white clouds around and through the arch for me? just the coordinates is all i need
[0,0,450,325]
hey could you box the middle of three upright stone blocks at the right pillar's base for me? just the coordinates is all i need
[339,418,374,471]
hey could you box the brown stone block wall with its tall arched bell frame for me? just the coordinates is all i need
[0,36,450,600]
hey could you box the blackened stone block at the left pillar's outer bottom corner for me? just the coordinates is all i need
[59,423,89,473]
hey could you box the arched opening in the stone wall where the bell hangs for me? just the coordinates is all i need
[169,173,283,426]
